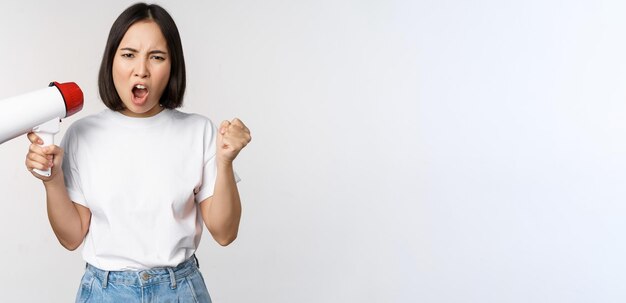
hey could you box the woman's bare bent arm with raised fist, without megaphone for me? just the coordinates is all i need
[200,118,252,246]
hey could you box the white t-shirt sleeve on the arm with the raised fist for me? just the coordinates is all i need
[195,120,241,203]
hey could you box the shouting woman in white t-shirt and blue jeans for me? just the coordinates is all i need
[26,3,251,302]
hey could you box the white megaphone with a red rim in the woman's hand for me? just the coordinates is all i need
[0,82,83,177]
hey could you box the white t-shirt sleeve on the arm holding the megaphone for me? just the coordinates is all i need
[60,126,87,207]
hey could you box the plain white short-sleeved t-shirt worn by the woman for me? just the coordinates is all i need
[61,109,227,270]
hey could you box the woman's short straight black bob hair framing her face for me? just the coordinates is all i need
[98,3,186,111]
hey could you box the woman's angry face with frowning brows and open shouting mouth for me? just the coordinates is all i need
[113,20,171,117]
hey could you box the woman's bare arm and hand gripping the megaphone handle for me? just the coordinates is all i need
[26,133,91,250]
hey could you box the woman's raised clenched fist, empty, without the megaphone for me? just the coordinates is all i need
[217,118,252,164]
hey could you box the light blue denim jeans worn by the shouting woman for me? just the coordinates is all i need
[76,256,211,303]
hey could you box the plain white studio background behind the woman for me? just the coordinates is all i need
[0,0,626,303]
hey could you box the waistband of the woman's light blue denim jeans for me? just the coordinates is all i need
[87,255,198,289]
